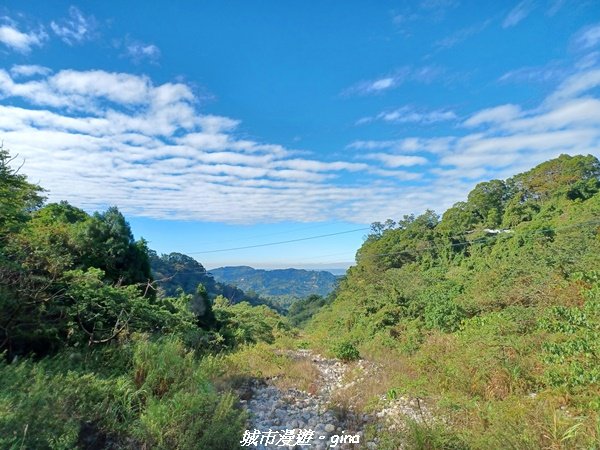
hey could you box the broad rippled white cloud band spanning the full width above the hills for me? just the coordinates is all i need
[0,60,600,229]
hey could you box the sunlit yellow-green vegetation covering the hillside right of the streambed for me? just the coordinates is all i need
[308,155,600,449]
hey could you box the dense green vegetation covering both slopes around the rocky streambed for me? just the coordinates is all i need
[0,149,600,450]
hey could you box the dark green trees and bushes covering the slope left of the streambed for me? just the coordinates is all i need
[0,149,288,449]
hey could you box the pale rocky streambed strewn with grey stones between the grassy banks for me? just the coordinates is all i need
[242,350,428,450]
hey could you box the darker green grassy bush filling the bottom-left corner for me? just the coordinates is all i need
[0,354,140,449]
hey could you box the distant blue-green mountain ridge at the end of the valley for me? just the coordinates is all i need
[210,266,338,298]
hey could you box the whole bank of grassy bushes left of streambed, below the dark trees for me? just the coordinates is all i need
[0,336,246,450]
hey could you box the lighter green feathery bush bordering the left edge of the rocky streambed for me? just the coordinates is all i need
[133,337,245,450]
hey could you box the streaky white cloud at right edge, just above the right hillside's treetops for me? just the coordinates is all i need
[452,71,600,171]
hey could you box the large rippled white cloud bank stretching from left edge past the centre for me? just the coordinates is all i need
[0,69,436,223]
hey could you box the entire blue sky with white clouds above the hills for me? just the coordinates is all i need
[0,0,600,268]
